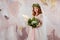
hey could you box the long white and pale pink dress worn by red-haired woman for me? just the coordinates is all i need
[27,14,48,40]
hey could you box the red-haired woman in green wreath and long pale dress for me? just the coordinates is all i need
[27,4,47,40]
